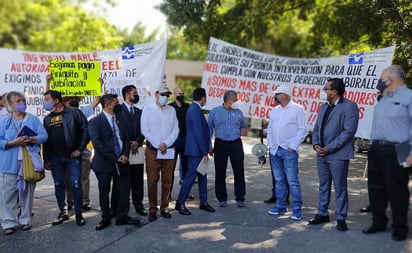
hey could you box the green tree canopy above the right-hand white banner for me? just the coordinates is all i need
[158,0,412,80]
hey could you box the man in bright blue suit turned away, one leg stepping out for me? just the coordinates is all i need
[175,88,215,215]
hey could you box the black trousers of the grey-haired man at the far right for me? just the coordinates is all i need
[368,144,410,233]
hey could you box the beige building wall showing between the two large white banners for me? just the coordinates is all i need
[165,60,204,90]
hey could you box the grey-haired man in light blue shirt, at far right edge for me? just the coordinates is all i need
[363,65,412,241]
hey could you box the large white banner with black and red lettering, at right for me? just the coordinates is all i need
[202,38,395,138]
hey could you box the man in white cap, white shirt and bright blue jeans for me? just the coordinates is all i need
[267,85,307,220]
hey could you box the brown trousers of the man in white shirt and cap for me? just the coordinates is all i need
[145,148,174,212]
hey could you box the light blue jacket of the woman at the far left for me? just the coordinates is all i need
[0,113,48,174]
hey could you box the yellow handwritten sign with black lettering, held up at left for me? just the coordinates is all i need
[49,60,101,97]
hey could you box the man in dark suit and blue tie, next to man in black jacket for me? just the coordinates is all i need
[89,94,139,230]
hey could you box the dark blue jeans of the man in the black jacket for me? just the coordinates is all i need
[50,156,83,214]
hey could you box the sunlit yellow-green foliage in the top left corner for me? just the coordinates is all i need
[0,0,122,52]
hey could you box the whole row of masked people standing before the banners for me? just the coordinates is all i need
[0,65,412,240]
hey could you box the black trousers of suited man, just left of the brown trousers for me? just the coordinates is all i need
[130,164,144,211]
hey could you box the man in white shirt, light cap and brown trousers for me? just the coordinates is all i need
[140,86,179,221]
